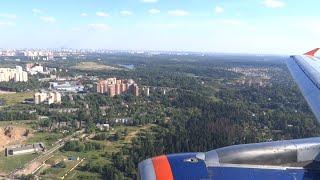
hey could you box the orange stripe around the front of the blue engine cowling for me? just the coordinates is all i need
[152,155,173,180]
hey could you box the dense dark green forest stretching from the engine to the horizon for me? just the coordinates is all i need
[61,57,320,179]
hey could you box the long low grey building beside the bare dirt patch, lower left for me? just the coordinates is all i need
[5,142,45,156]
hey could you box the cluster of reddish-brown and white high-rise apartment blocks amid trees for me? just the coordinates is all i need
[96,78,139,97]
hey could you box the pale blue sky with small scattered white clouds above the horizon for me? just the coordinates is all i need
[0,0,320,54]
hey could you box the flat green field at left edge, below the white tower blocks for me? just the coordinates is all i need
[0,92,33,106]
